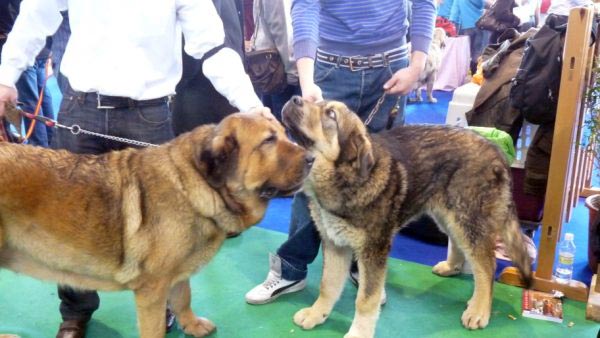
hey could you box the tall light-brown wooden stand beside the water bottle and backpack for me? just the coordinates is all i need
[499,8,597,302]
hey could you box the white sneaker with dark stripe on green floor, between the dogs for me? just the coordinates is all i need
[246,254,306,305]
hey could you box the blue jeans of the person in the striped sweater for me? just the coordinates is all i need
[277,53,408,280]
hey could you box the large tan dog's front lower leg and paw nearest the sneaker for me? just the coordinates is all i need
[169,279,215,337]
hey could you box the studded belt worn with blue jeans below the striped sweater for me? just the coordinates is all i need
[317,46,408,71]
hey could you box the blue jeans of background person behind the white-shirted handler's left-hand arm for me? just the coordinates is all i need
[15,58,56,147]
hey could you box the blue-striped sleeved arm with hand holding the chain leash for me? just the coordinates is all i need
[383,0,436,95]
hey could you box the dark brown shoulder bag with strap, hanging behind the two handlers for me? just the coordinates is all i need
[244,0,287,95]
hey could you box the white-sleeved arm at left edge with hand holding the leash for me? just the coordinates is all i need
[0,0,66,116]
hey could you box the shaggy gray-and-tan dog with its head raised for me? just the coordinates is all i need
[283,97,531,337]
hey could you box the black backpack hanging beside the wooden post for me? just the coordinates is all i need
[509,15,566,124]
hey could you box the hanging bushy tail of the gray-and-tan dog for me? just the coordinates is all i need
[500,213,533,289]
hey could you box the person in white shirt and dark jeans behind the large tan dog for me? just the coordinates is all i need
[0,0,274,338]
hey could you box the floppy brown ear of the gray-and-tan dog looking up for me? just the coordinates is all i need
[338,130,375,178]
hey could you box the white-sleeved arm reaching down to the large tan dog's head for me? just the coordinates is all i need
[177,0,263,111]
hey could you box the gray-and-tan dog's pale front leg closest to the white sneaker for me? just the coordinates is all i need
[294,238,352,330]
